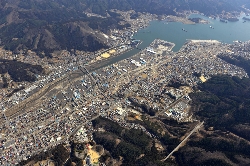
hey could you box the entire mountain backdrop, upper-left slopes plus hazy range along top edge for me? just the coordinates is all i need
[0,0,246,55]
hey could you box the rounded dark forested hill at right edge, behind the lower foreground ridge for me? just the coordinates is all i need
[191,75,250,138]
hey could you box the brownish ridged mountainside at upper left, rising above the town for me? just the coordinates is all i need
[0,0,128,55]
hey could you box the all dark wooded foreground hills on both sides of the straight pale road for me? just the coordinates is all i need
[18,75,250,166]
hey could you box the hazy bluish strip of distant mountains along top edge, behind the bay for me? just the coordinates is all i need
[12,0,247,15]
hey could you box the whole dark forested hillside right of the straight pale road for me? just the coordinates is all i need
[175,76,250,165]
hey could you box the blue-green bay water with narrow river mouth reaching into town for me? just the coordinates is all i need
[99,14,250,65]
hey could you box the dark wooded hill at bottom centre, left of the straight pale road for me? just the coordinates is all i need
[92,117,175,166]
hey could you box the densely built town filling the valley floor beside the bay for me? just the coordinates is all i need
[0,10,249,165]
